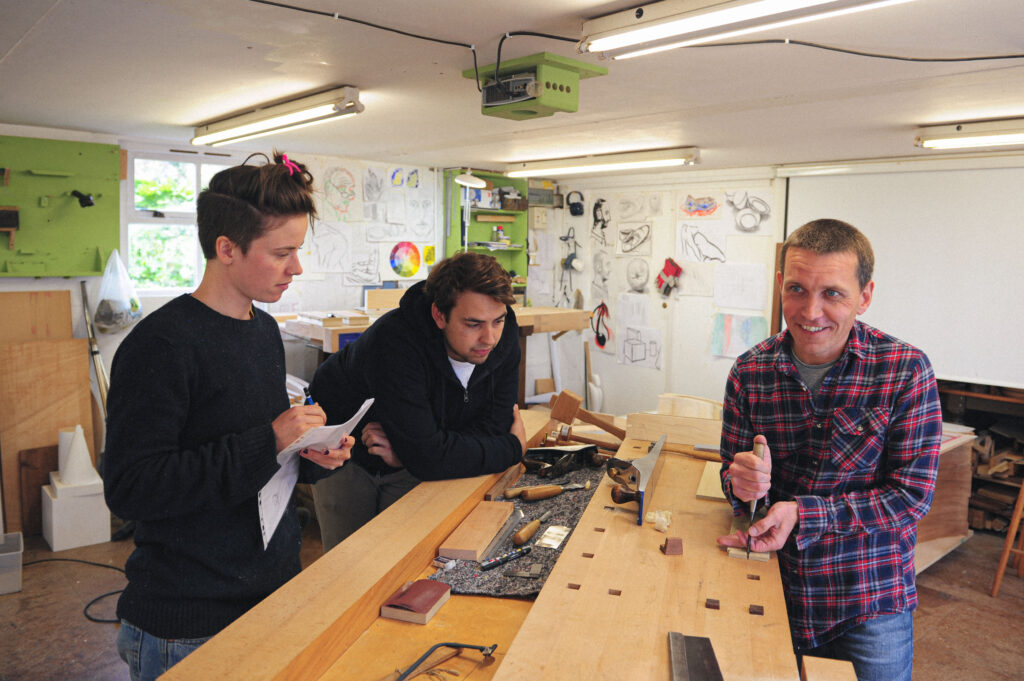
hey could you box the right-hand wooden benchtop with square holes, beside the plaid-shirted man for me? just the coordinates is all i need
[494,415,798,681]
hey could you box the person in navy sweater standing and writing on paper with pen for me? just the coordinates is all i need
[102,155,354,681]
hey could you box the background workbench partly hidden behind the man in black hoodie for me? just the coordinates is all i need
[276,305,590,409]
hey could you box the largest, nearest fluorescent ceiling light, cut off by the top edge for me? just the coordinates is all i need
[579,0,913,59]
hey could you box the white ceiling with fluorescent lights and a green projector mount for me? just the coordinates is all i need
[0,0,1024,173]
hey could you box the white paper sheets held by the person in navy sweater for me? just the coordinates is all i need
[257,397,374,550]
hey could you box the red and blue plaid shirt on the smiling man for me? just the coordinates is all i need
[722,322,942,649]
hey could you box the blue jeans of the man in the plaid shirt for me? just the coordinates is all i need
[797,610,913,681]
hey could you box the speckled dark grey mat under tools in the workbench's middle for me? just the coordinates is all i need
[430,467,604,597]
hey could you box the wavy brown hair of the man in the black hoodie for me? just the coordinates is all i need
[423,252,515,320]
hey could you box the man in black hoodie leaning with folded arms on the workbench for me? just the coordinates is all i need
[310,253,526,551]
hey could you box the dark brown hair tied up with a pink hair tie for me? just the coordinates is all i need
[196,152,316,260]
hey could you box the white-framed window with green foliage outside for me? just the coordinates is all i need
[122,150,244,293]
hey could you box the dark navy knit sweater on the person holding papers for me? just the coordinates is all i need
[102,295,328,638]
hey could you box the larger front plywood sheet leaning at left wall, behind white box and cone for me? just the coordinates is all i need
[0,338,96,533]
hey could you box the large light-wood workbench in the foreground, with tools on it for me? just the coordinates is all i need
[162,410,831,681]
